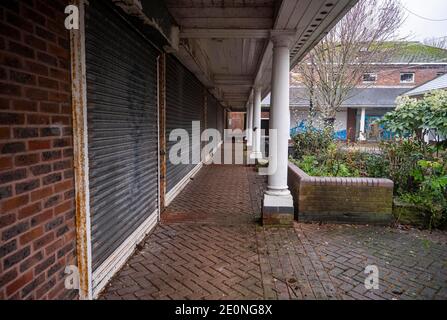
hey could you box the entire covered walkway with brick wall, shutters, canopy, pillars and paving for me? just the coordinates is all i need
[0,0,447,299]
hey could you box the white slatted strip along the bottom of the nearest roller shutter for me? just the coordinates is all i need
[92,209,159,299]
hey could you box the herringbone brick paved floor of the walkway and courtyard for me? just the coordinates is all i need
[100,165,447,299]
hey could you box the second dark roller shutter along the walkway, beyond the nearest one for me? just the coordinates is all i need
[166,56,203,192]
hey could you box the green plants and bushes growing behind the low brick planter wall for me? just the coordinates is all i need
[291,122,447,228]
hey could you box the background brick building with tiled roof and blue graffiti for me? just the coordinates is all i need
[263,42,447,141]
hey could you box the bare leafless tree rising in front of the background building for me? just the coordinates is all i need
[298,0,404,127]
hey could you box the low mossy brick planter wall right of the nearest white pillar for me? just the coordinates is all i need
[288,163,393,224]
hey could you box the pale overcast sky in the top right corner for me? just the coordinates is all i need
[400,0,447,41]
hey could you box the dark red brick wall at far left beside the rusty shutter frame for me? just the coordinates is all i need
[0,0,75,299]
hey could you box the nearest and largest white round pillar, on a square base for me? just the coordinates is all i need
[262,32,294,225]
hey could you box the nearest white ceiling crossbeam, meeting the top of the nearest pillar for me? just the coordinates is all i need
[180,28,270,39]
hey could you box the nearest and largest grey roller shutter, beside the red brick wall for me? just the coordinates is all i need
[86,0,158,271]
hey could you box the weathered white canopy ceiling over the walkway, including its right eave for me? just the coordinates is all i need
[166,0,357,111]
